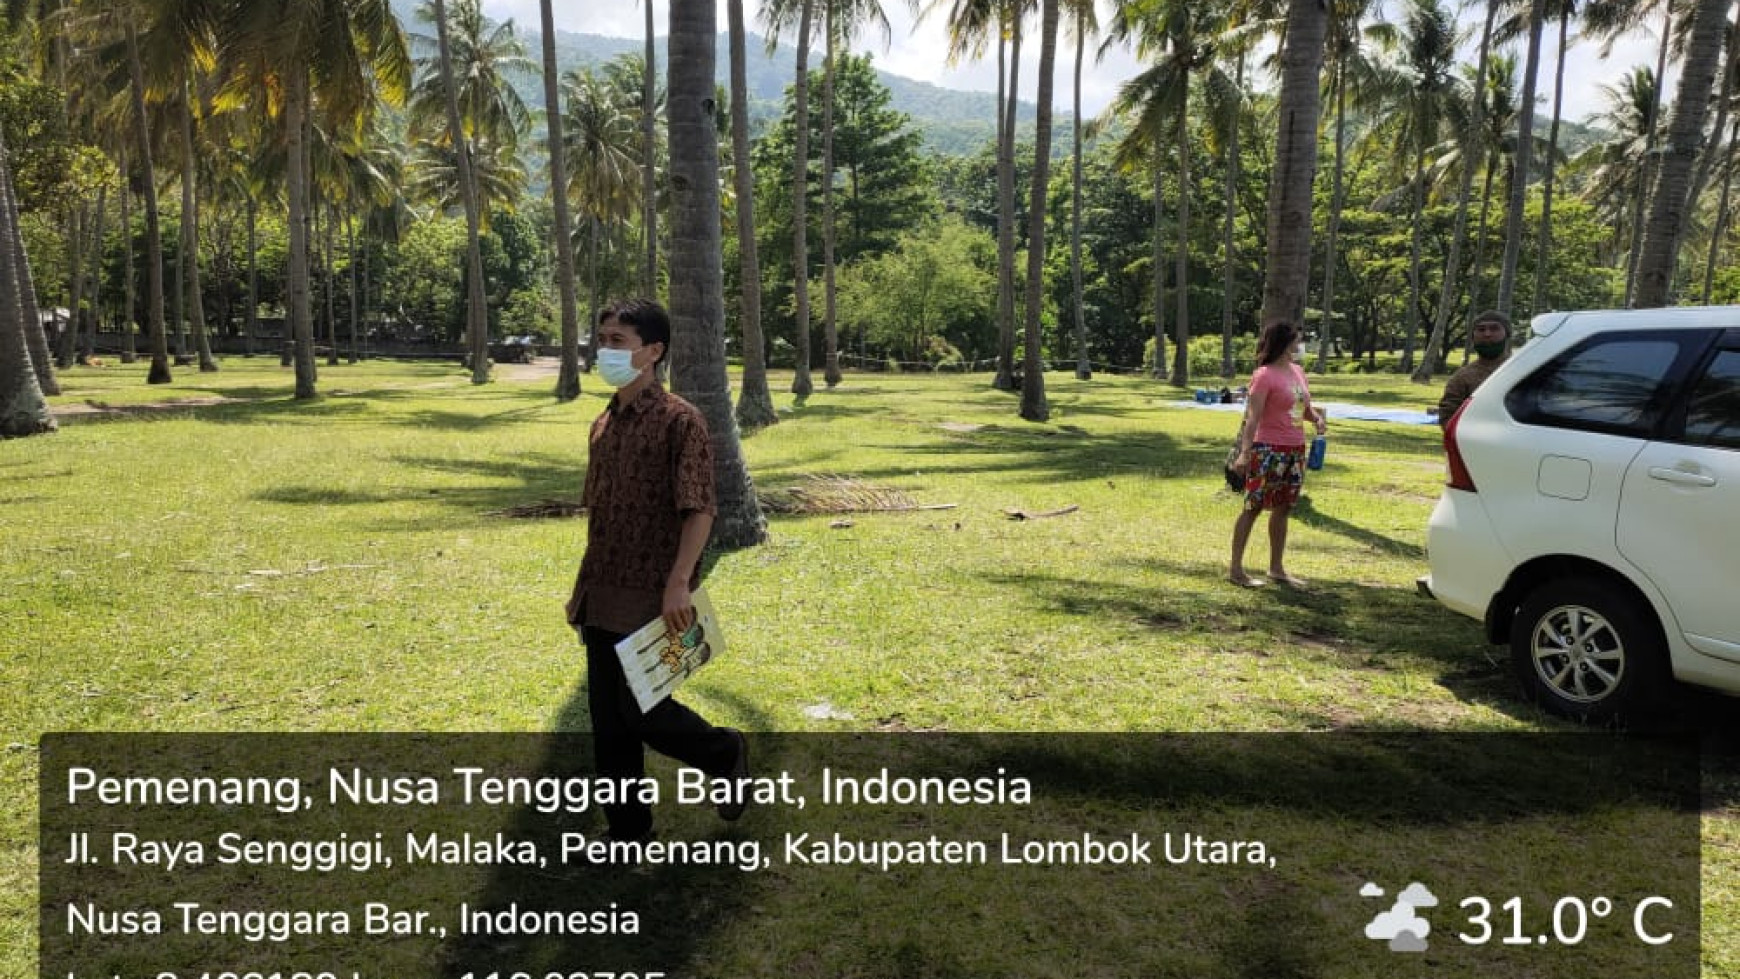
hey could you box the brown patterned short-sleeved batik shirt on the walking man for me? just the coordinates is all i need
[567,383,715,633]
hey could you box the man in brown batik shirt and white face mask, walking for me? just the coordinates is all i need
[567,299,748,840]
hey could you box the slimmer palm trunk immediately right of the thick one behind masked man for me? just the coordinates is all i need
[726,0,780,431]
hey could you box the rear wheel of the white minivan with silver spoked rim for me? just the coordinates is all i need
[1510,577,1665,723]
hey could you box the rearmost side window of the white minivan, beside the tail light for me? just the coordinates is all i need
[1505,336,1683,436]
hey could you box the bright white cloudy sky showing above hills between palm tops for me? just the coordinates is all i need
[484,0,1674,128]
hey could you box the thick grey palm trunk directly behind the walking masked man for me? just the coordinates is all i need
[666,3,767,548]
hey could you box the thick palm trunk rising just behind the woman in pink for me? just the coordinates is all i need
[1263,0,1329,323]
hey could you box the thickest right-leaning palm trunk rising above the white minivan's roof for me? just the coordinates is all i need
[1636,0,1733,308]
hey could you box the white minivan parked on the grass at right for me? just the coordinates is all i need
[1420,306,1740,722]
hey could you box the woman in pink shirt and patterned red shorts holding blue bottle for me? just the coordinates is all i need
[1227,322,1328,588]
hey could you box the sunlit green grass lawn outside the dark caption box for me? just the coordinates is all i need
[0,358,1740,977]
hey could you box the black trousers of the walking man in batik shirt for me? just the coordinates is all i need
[581,626,738,840]
